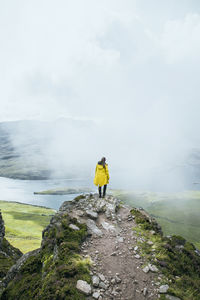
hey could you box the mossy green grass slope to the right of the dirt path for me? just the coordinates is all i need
[131,209,200,300]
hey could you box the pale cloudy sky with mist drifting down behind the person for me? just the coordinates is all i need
[0,0,200,190]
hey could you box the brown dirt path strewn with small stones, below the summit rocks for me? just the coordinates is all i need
[77,200,161,300]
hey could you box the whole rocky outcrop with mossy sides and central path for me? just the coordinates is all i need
[0,194,200,300]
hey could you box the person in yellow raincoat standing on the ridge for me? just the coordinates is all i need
[94,157,110,198]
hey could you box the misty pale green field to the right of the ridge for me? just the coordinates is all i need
[113,190,200,249]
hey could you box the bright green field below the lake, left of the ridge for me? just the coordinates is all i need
[0,200,55,253]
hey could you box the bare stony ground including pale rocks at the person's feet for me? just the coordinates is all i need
[60,194,178,300]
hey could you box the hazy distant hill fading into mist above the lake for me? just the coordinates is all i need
[0,119,94,179]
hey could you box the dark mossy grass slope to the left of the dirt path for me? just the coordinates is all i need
[0,214,91,300]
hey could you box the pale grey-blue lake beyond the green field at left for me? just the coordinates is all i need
[0,177,96,210]
